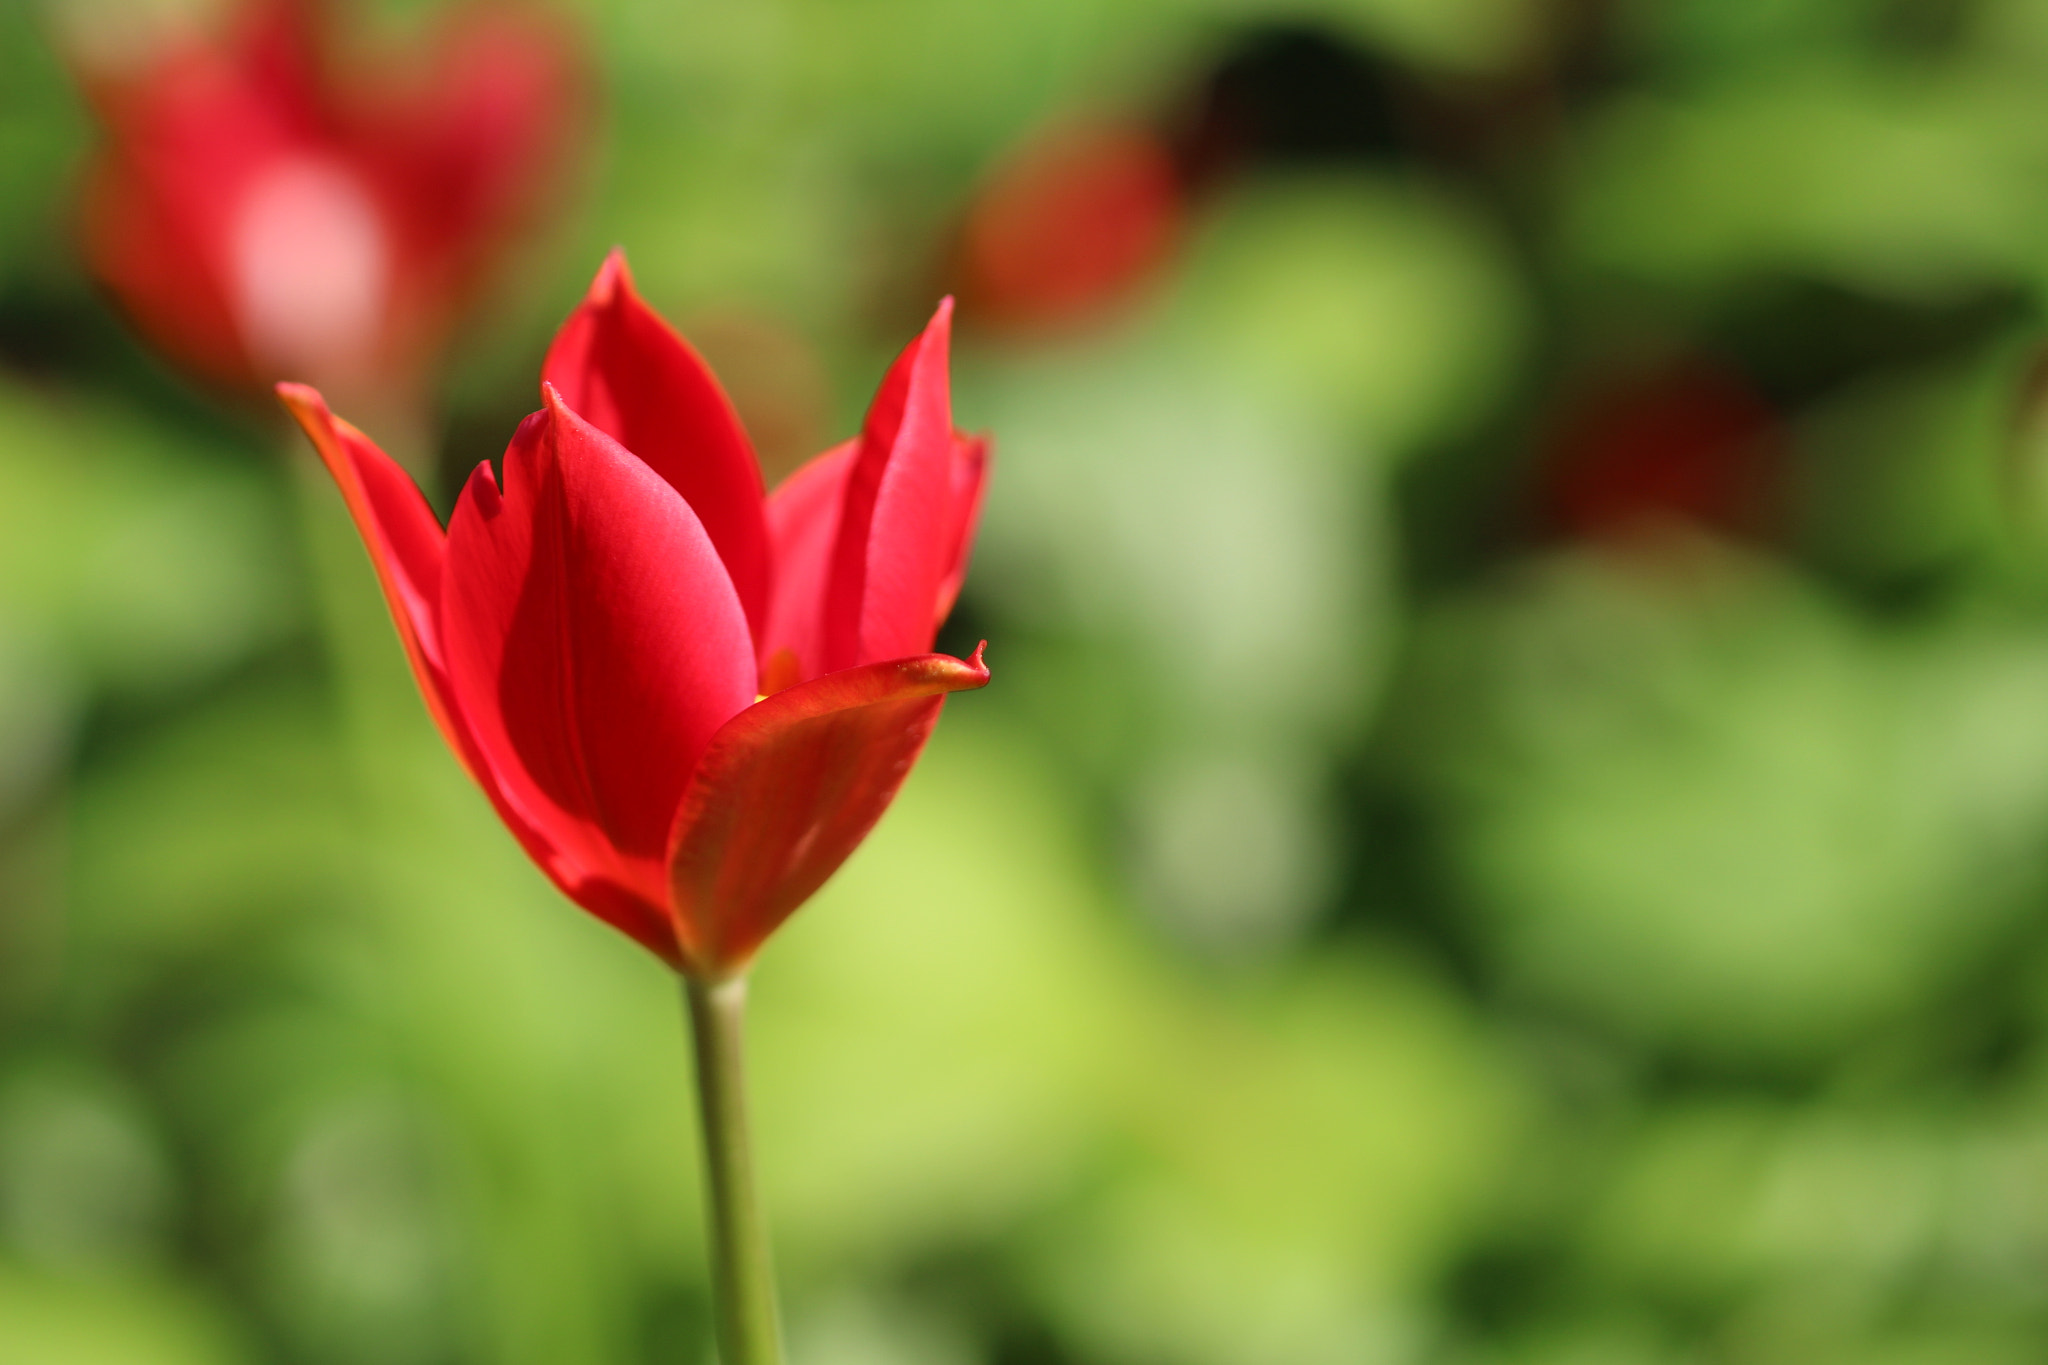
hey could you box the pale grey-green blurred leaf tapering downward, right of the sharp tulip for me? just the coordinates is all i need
[963,329,1393,952]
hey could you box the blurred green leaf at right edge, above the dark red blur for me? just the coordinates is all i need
[1565,57,2048,297]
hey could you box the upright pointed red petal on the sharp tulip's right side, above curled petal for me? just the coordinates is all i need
[825,299,958,669]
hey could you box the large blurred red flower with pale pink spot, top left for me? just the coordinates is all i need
[72,0,582,401]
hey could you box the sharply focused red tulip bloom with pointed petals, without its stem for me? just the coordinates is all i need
[279,254,989,978]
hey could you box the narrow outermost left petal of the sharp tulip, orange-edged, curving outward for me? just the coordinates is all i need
[276,385,678,964]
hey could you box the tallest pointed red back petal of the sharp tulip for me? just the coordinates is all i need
[543,250,768,634]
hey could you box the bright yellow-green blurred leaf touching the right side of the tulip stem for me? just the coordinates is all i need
[754,716,1153,1265]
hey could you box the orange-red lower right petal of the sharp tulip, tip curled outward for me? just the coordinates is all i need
[668,649,989,976]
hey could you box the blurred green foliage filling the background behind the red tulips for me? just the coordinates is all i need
[0,0,2048,1365]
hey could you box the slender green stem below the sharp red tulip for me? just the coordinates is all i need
[684,976,782,1365]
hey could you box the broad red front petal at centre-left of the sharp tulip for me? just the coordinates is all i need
[440,387,756,909]
